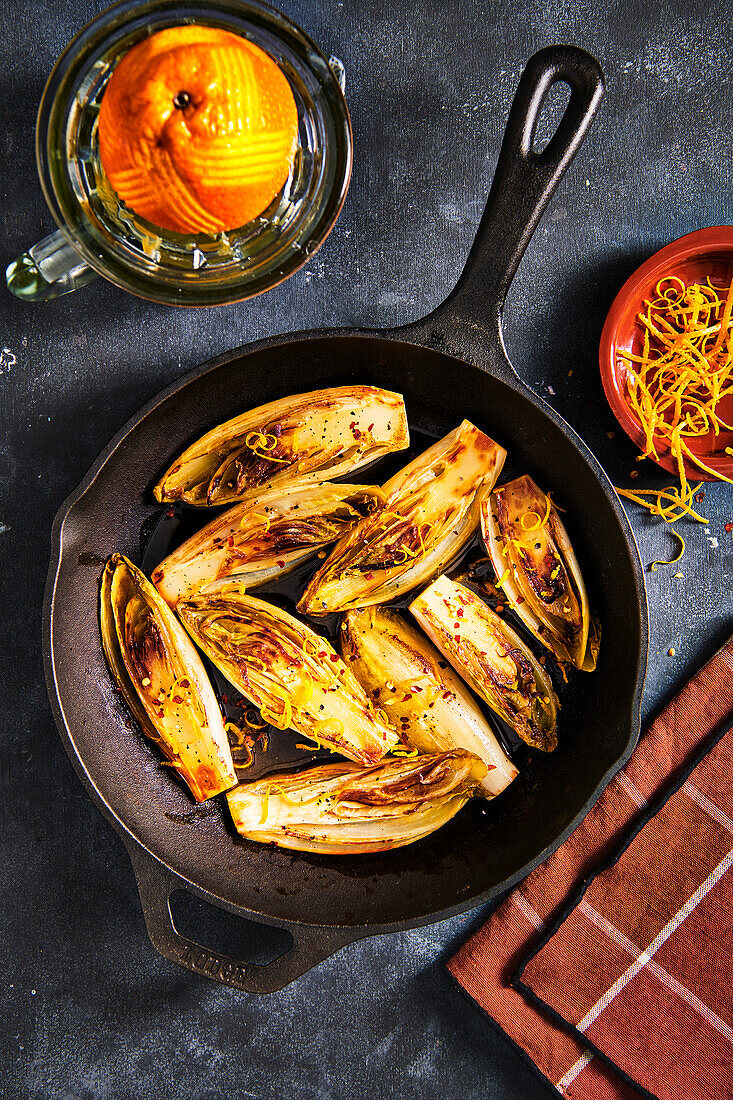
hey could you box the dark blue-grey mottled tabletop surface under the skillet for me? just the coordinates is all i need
[0,0,733,1100]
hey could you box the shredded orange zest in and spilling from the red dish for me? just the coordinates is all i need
[616,276,733,570]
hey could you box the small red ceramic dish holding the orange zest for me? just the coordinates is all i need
[599,226,733,481]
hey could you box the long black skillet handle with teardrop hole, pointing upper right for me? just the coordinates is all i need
[394,46,604,373]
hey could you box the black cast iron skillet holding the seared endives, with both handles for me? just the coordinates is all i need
[44,46,647,992]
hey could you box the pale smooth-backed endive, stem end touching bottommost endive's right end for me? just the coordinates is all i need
[340,607,518,799]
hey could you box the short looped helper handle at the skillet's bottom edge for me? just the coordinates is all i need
[125,842,359,993]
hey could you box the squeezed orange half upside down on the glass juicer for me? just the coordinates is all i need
[99,26,298,234]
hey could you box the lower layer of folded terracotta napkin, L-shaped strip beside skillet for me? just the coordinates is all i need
[448,639,733,1100]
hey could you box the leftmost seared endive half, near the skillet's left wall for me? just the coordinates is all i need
[99,554,237,802]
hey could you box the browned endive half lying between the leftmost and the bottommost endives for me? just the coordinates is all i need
[176,581,398,765]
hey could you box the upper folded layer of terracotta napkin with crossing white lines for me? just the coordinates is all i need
[515,708,733,1100]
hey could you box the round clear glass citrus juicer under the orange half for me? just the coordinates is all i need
[6,0,352,306]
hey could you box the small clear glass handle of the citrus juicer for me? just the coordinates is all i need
[6,229,97,301]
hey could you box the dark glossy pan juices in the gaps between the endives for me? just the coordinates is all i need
[140,425,572,792]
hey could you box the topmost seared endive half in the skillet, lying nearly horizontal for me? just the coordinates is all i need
[155,386,409,506]
